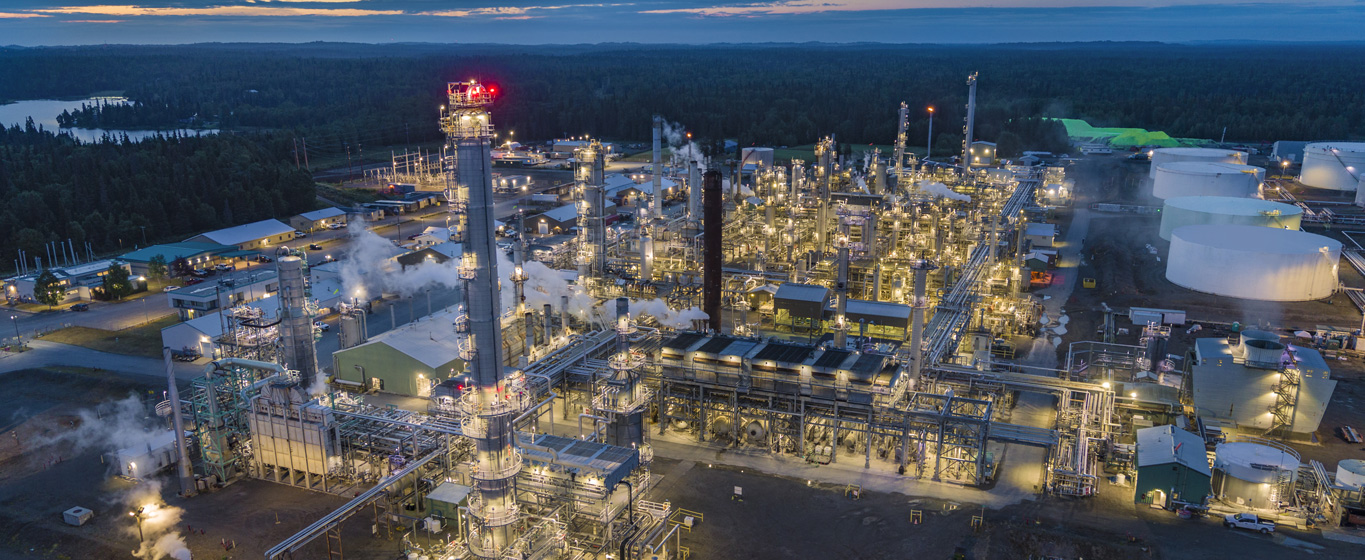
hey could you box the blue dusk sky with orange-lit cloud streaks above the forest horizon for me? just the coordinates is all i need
[0,0,1365,45]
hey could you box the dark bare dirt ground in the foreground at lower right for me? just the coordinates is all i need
[651,459,1361,560]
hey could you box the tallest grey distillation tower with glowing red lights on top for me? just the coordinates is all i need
[441,81,521,559]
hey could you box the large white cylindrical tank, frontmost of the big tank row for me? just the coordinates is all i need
[1166,225,1342,302]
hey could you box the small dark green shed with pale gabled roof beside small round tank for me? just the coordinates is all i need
[1133,426,1213,507]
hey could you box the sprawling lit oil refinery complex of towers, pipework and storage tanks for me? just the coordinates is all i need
[8,74,1365,560]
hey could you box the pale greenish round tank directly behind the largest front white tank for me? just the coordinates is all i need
[1159,197,1304,240]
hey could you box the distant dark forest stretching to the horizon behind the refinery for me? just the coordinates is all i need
[0,44,1365,158]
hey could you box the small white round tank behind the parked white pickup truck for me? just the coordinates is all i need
[1213,441,1298,509]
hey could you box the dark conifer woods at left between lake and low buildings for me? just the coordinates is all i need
[0,127,315,258]
